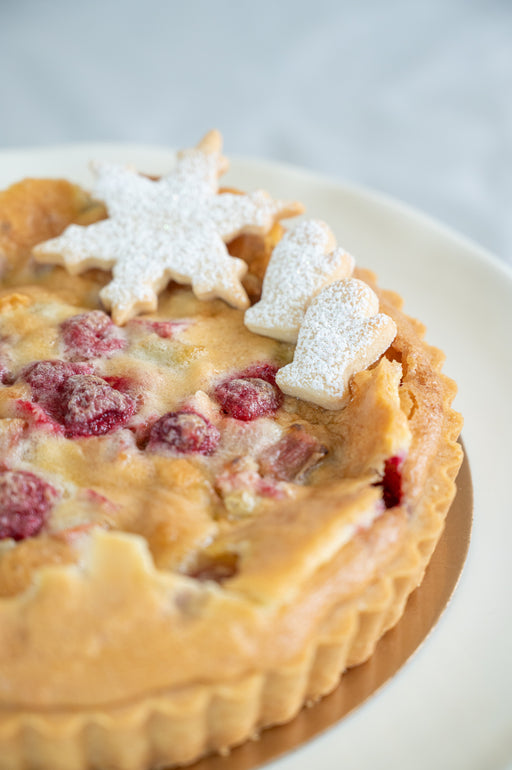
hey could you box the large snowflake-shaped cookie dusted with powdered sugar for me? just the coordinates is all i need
[34,131,302,324]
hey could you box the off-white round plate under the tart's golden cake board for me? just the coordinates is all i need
[0,145,512,770]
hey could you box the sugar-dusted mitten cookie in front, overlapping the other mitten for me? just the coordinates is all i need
[276,278,396,409]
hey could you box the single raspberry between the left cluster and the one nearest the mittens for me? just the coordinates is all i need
[148,411,220,455]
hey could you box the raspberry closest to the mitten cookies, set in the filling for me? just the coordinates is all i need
[215,377,283,422]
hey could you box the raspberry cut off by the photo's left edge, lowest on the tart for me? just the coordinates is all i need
[0,470,57,540]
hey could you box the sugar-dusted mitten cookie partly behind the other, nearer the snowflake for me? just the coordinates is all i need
[244,219,354,342]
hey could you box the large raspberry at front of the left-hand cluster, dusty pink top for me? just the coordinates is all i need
[59,374,135,438]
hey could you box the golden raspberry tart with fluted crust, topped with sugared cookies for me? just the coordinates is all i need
[0,133,462,770]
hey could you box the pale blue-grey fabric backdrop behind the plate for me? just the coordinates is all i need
[0,0,512,265]
